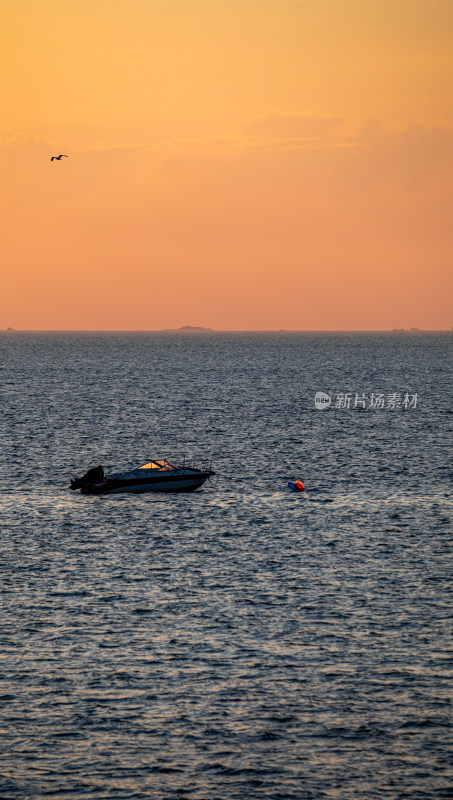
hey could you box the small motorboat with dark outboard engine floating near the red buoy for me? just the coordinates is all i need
[71,459,215,494]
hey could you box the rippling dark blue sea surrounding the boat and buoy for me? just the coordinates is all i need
[0,331,453,800]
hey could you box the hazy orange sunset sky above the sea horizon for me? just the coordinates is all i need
[0,0,453,330]
